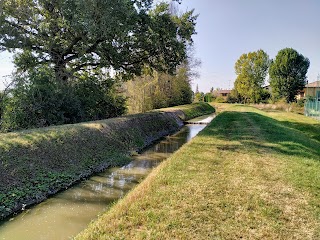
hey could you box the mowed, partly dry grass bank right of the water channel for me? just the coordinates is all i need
[77,105,320,239]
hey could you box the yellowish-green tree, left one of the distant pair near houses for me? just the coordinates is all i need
[234,49,270,103]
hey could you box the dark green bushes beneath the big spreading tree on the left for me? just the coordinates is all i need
[1,67,125,131]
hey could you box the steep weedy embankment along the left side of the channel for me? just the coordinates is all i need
[0,104,214,220]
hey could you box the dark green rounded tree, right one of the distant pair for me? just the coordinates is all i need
[269,48,310,102]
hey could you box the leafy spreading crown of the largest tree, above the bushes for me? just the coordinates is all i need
[0,0,196,82]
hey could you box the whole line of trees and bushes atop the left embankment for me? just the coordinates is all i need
[0,0,197,131]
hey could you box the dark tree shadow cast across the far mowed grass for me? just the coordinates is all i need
[200,112,320,161]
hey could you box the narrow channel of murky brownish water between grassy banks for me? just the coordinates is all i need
[0,116,212,240]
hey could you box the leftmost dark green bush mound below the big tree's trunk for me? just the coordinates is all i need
[1,68,82,131]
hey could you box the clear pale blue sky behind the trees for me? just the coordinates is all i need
[0,0,320,92]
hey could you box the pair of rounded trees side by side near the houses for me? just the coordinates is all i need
[231,48,310,103]
